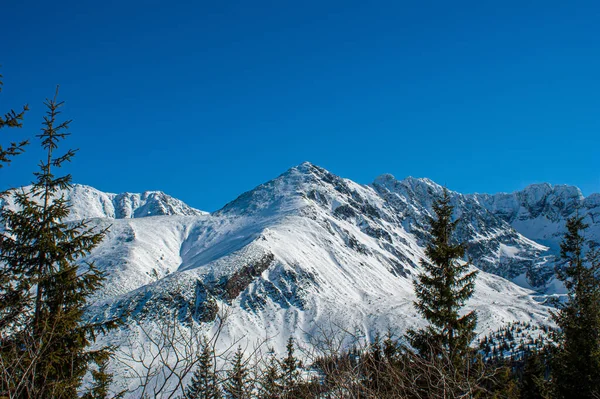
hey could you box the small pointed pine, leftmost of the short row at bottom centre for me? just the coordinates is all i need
[185,339,222,399]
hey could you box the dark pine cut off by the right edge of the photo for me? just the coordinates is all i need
[552,217,600,399]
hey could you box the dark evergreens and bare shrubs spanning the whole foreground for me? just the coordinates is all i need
[0,72,600,399]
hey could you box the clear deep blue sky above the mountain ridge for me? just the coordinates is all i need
[0,0,600,211]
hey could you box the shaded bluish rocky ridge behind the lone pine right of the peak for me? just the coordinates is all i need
[372,175,547,286]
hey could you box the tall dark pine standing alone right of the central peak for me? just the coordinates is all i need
[408,189,477,363]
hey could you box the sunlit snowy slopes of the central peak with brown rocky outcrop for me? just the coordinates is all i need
[82,163,549,370]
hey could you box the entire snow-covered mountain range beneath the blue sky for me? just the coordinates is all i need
[5,163,600,394]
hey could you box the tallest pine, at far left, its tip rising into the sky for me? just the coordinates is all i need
[0,91,114,399]
